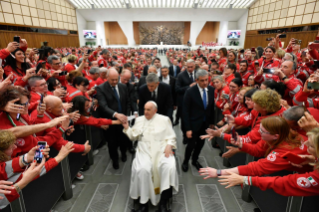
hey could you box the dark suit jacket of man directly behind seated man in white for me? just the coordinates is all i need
[138,82,173,118]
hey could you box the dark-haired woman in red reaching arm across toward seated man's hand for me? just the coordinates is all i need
[69,96,122,130]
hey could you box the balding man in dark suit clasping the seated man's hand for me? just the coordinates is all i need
[96,68,130,169]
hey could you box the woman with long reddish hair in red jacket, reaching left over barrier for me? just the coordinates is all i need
[199,116,312,182]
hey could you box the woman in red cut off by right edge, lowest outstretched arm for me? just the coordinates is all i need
[219,128,319,196]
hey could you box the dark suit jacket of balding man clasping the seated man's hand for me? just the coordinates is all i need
[96,82,130,120]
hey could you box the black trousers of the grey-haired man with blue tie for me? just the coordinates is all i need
[184,123,206,163]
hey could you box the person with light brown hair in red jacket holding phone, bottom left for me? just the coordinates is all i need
[0,130,73,205]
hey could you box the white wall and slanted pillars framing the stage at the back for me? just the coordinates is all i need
[77,9,248,46]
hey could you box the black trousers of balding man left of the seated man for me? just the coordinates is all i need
[105,126,131,161]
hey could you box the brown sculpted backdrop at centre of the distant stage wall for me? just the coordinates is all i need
[139,22,185,45]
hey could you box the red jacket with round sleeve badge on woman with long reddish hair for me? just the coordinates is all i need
[237,142,313,176]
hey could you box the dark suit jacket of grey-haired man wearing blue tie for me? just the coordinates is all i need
[183,85,214,132]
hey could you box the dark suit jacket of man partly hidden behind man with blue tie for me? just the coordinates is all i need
[175,70,196,108]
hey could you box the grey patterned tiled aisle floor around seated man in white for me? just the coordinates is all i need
[53,56,256,212]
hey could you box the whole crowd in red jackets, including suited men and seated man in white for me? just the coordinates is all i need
[0,31,319,212]
